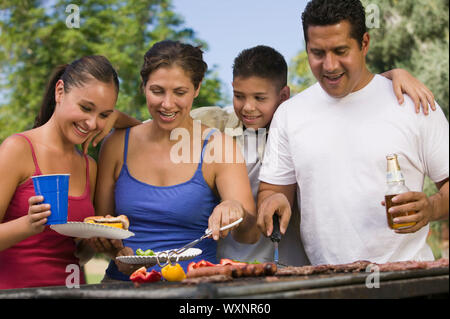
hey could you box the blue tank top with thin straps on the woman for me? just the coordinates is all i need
[106,128,220,280]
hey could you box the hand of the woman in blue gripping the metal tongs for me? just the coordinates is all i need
[208,200,245,240]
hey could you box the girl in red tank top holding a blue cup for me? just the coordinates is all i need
[0,56,123,289]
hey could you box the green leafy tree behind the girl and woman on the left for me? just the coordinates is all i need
[0,0,221,142]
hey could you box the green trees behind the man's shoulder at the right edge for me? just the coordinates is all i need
[362,0,449,118]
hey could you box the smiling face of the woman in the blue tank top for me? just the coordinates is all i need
[144,65,200,130]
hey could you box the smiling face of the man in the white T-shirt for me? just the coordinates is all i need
[307,20,372,98]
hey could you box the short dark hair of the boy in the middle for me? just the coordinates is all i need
[233,45,288,90]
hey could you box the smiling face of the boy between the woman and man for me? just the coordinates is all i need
[233,76,289,130]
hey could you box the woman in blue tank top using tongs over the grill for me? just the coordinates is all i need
[95,41,259,280]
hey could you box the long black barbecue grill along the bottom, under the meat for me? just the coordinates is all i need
[0,267,449,299]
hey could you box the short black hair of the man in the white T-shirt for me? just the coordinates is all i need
[302,0,367,48]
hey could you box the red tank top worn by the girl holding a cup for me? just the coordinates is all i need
[0,134,95,289]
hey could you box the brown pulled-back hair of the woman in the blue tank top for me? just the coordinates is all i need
[141,40,208,89]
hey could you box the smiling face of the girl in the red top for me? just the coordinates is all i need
[54,79,117,144]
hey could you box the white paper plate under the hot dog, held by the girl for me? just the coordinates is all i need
[50,222,134,239]
